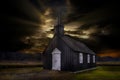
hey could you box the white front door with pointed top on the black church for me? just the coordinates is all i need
[52,48,61,71]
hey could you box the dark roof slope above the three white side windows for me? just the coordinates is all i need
[61,36,95,54]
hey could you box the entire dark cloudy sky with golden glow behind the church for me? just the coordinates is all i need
[0,0,120,57]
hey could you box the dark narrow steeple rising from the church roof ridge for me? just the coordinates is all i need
[54,13,64,35]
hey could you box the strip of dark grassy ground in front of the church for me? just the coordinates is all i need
[0,66,120,80]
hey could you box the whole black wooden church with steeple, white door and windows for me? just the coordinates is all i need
[43,14,96,72]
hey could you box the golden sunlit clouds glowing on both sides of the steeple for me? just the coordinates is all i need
[17,0,116,53]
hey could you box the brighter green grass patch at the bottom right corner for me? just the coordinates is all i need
[74,66,120,80]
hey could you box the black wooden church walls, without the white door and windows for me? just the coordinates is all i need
[43,36,95,71]
